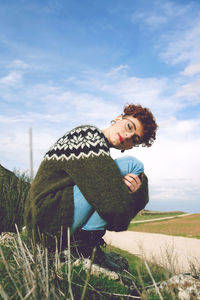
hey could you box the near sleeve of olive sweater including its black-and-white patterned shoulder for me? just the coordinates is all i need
[45,126,148,231]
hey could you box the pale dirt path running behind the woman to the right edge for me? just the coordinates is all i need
[105,231,200,273]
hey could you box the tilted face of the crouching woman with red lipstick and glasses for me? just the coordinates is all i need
[107,115,143,150]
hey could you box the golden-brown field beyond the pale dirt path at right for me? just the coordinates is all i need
[129,214,200,238]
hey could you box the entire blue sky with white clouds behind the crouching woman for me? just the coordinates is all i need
[0,0,200,212]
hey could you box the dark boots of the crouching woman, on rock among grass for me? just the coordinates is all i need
[71,230,129,272]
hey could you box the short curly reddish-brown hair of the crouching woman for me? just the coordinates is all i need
[124,104,158,147]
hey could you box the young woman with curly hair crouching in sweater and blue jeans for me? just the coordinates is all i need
[25,104,157,268]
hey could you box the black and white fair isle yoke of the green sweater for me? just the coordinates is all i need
[44,126,110,160]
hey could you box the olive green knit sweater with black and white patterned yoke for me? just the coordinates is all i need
[25,126,148,250]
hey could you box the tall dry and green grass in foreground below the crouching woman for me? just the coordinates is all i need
[0,229,177,300]
